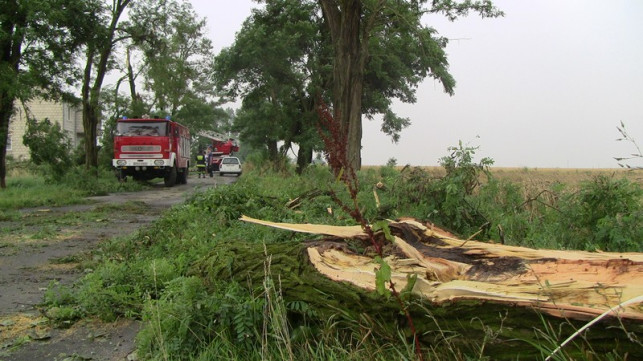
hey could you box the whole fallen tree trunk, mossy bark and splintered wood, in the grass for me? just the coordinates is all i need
[192,217,643,359]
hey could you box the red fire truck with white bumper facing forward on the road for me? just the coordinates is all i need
[112,117,190,187]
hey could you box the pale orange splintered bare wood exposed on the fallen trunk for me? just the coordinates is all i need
[241,216,643,320]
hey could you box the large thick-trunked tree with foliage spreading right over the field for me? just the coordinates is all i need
[319,0,502,169]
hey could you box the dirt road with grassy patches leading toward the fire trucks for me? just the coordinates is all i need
[0,175,236,361]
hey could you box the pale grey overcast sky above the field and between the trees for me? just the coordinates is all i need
[191,0,643,168]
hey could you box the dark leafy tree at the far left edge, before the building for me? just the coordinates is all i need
[0,0,96,188]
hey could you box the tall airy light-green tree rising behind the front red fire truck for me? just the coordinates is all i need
[127,0,221,131]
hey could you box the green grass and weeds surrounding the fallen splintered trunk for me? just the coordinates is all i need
[36,167,641,361]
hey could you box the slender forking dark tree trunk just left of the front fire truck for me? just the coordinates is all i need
[81,0,131,168]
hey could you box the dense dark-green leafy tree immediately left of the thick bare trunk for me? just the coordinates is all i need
[214,0,323,171]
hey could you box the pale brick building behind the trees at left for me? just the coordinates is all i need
[7,100,84,160]
